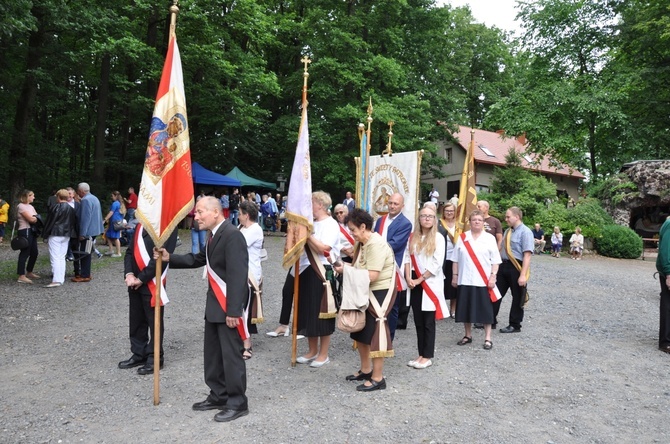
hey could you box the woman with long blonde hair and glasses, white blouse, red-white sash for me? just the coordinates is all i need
[403,206,449,369]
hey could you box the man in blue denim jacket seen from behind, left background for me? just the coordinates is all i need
[72,182,105,282]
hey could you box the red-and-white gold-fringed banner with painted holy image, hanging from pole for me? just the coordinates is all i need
[136,33,193,247]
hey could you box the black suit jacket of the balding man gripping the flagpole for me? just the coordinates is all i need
[170,220,249,323]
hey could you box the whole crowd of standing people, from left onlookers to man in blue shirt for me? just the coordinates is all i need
[5,183,535,421]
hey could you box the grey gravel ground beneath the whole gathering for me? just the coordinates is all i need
[0,236,670,443]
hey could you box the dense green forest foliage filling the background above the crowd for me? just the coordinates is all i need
[0,0,670,209]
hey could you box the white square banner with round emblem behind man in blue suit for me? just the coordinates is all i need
[367,151,423,225]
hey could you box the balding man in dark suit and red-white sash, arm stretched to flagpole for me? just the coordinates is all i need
[155,196,249,422]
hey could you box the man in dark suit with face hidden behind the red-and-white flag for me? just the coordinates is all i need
[119,224,177,375]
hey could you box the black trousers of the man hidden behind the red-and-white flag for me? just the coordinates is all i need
[128,289,165,364]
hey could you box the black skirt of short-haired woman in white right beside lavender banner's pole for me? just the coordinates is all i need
[298,266,335,338]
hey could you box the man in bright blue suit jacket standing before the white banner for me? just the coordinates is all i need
[375,193,412,339]
